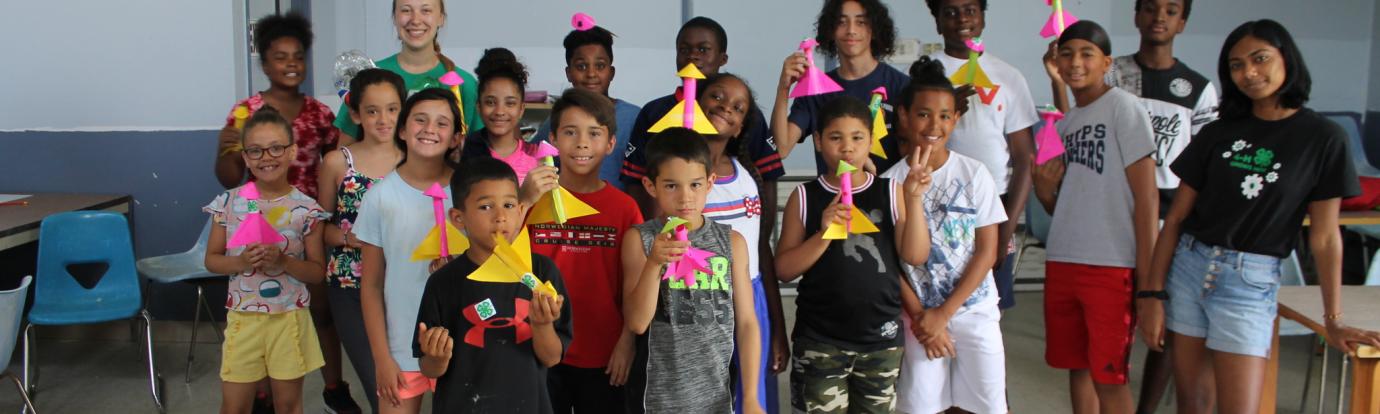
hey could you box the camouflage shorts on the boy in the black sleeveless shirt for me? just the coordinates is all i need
[791,338,903,413]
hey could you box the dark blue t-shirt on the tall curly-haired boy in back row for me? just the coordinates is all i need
[789,63,911,174]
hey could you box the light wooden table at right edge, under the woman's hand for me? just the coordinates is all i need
[1260,286,1380,414]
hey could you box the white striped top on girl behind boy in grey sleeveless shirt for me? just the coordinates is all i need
[704,160,762,279]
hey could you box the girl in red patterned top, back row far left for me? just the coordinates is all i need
[215,12,338,200]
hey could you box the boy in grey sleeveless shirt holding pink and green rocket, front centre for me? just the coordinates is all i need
[622,127,762,413]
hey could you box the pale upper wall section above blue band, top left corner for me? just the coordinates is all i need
[0,0,236,130]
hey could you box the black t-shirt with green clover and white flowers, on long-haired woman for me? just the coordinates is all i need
[1173,108,1361,257]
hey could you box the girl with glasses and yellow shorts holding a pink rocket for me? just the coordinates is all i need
[201,108,330,413]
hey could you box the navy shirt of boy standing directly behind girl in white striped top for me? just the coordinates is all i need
[622,94,785,184]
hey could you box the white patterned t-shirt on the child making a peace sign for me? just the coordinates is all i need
[882,151,1006,309]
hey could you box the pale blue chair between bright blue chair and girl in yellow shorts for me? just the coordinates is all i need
[134,219,225,384]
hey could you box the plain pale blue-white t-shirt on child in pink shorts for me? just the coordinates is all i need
[351,171,460,371]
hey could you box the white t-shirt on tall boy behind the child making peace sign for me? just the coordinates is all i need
[930,51,1039,195]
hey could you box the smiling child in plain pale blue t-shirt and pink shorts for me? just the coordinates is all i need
[353,88,461,413]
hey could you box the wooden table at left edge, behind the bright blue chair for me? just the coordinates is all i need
[0,193,134,251]
